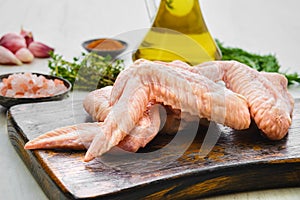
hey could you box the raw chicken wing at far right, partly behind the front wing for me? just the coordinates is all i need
[191,61,294,140]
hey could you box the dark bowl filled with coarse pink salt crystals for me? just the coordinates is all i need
[0,72,72,108]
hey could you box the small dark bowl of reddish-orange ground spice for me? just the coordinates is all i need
[82,38,127,58]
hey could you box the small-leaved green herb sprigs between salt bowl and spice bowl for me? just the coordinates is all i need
[48,52,124,91]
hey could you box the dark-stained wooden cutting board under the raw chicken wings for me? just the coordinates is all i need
[8,100,300,199]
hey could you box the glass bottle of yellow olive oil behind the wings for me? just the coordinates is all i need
[133,0,221,65]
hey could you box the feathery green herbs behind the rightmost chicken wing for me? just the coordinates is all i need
[216,40,300,85]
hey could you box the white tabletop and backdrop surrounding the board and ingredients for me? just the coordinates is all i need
[0,0,300,200]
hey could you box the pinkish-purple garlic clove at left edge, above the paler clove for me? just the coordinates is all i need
[0,33,26,53]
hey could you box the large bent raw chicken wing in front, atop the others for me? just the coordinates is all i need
[25,60,250,161]
